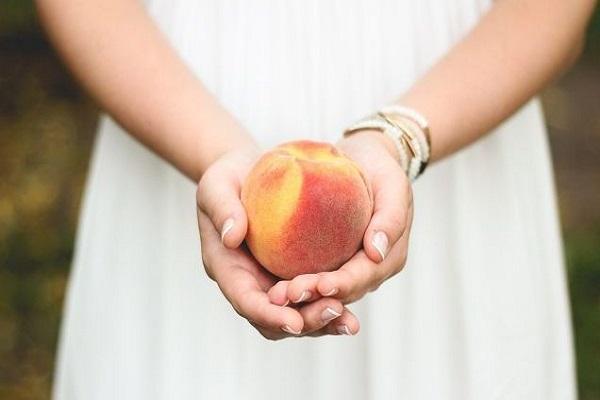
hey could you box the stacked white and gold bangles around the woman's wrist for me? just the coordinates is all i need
[344,105,431,181]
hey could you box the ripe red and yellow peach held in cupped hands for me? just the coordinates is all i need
[242,141,373,279]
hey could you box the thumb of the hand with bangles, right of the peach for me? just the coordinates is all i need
[363,166,412,263]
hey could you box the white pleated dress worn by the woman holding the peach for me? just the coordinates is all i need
[54,0,575,400]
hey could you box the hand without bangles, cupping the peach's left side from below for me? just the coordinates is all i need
[196,147,358,340]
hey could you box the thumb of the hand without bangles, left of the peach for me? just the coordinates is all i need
[196,170,248,249]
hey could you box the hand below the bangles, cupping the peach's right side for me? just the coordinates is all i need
[269,131,413,310]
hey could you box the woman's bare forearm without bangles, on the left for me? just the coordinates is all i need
[37,0,252,181]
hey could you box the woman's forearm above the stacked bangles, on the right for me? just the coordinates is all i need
[400,0,595,161]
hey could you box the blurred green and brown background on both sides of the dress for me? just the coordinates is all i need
[0,0,600,400]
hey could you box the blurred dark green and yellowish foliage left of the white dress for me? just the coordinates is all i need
[0,0,96,400]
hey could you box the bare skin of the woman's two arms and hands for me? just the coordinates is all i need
[37,0,595,339]
